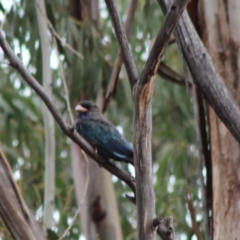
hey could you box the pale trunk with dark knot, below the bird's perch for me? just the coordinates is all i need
[72,143,123,240]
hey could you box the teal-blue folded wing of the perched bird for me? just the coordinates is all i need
[77,119,133,159]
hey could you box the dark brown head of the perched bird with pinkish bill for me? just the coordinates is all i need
[75,100,101,119]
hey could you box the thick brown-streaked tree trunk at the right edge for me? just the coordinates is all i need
[200,0,240,240]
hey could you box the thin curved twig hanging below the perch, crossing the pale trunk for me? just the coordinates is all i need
[58,151,89,240]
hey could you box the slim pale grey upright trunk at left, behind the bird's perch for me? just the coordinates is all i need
[35,0,55,228]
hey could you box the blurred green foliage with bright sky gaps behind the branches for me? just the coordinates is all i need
[0,0,203,240]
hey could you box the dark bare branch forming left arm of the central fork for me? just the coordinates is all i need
[105,0,138,88]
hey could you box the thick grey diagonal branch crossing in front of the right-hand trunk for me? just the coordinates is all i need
[158,0,240,142]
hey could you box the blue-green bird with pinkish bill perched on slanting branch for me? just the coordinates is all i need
[75,100,133,164]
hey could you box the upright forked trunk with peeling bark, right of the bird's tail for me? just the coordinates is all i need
[133,0,188,240]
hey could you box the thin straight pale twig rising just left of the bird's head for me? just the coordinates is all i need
[53,37,74,124]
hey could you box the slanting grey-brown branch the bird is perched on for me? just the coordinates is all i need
[0,32,135,199]
